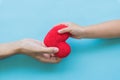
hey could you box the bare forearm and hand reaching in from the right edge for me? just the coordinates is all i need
[58,20,120,39]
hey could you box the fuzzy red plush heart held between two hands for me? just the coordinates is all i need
[44,24,71,58]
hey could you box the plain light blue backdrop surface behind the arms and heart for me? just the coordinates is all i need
[0,0,120,80]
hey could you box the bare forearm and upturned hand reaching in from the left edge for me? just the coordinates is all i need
[0,39,61,63]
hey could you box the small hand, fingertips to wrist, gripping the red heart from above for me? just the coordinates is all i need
[58,22,84,39]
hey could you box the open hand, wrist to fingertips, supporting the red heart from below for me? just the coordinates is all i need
[18,39,61,63]
